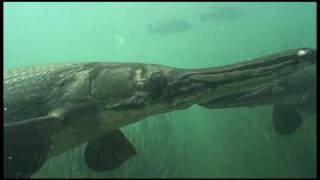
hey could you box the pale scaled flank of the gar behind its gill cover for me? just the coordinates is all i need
[4,64,82,122]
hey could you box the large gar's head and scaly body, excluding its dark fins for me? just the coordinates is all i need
[4,48,315,177]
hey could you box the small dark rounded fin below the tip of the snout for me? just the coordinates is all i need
[272,105,302,135]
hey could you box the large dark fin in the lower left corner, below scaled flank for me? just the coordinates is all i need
[4,116,56,178]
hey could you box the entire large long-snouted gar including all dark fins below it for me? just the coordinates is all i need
[4,48,316,177]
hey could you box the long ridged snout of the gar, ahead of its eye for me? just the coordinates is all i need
[168,48,316,108]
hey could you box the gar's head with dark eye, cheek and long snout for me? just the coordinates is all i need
[91,48,316,128]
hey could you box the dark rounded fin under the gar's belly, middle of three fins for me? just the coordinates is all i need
[85,130,137,171]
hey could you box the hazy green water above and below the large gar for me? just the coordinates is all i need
[4,2,316,178]
